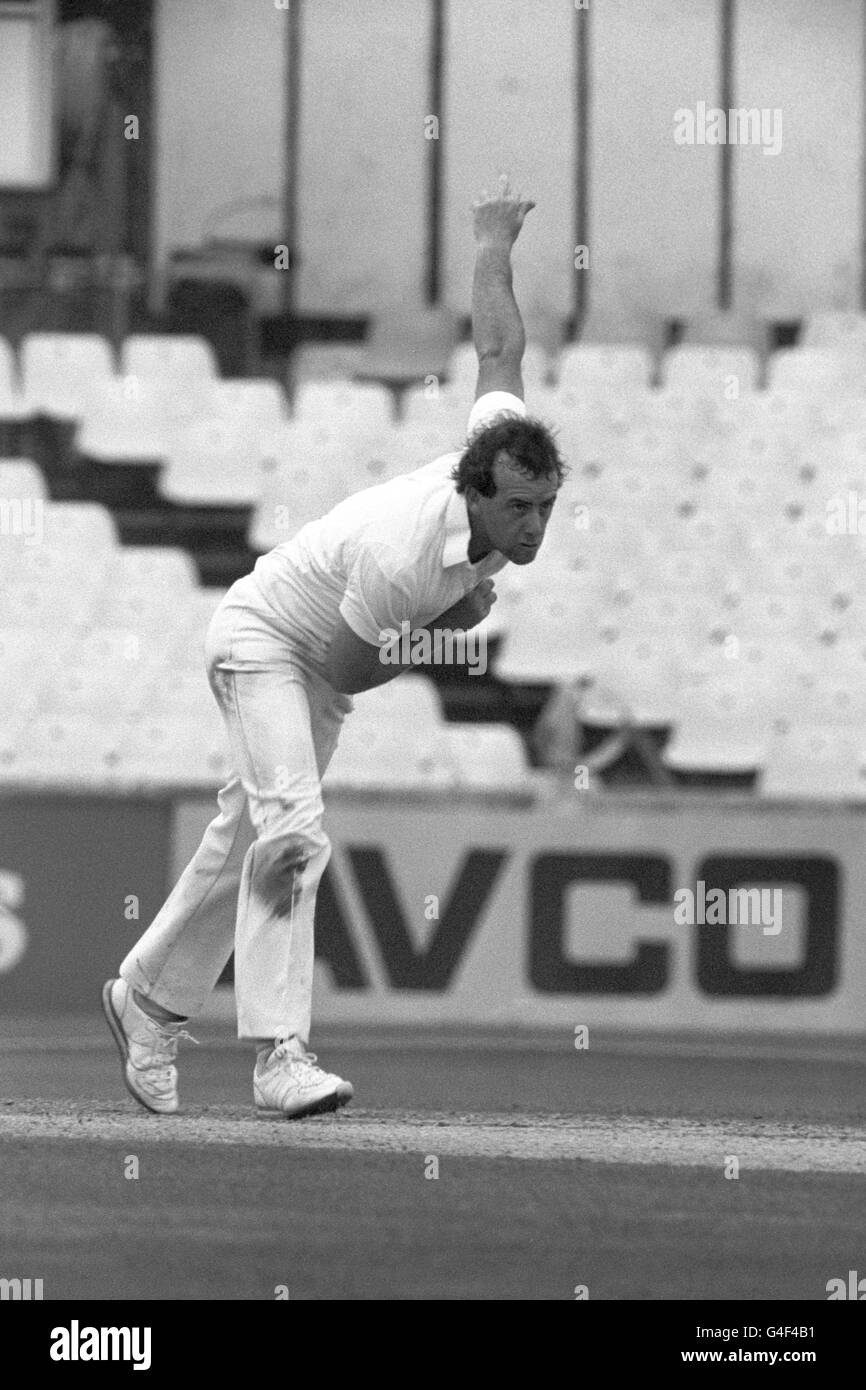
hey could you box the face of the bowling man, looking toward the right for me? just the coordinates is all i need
[466,449,559,564]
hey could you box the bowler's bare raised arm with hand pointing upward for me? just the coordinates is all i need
[473,174,535,400]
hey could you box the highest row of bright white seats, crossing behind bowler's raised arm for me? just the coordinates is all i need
[8,334,866,441]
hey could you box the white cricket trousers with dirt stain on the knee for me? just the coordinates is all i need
[120,575,353,1044]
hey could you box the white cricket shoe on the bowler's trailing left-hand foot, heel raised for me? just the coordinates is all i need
[103,980,196,1115]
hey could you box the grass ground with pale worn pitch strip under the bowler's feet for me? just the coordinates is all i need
[0,1019,866,1300]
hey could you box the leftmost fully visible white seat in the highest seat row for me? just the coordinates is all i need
[19,334,115,420]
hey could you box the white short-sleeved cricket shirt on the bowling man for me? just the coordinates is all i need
[252,391,527,664]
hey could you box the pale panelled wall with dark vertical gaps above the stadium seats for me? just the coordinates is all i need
[154,0,865,317]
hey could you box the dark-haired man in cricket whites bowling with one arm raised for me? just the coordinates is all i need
[103,175,563,1116]
